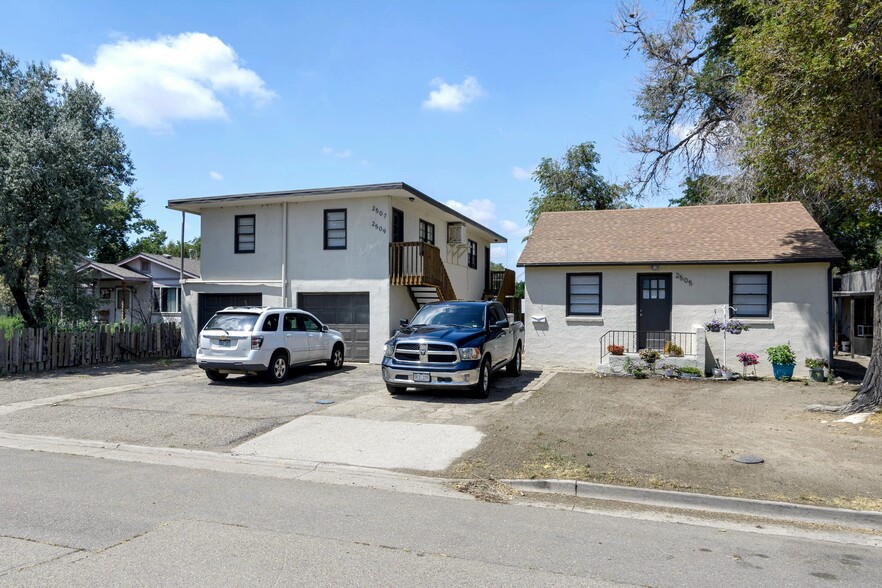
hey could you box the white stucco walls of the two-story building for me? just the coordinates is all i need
[182,195,502,363]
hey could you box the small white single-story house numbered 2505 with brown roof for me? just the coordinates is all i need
[518,202,842,375]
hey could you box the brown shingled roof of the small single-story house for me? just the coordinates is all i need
[518,202,843,266]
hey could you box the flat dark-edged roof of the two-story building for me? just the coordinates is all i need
[168,182,508,243]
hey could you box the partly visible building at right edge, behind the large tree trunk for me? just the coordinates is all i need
[833,268,878,356]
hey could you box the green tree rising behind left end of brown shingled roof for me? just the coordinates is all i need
[527,142,630,229]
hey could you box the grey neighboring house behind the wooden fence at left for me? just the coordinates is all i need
[77,253,200,324]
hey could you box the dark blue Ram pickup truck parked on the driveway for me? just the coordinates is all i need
[383,301,524,398]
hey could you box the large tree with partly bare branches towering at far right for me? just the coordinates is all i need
[619,0,882,412]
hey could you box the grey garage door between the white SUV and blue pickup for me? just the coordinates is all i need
[297,292,371,361]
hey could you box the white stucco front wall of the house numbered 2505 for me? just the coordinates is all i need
[525,263,829,375]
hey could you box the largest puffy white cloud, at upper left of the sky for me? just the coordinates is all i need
[52,33,275,130]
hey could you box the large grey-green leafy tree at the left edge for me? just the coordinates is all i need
[0,52,133,326]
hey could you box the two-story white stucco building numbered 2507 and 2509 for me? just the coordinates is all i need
[168,183,514,363]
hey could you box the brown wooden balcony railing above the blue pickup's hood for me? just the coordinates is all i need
[389,241,456,300]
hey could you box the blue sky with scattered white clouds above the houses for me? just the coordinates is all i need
[0,0,669,274]
